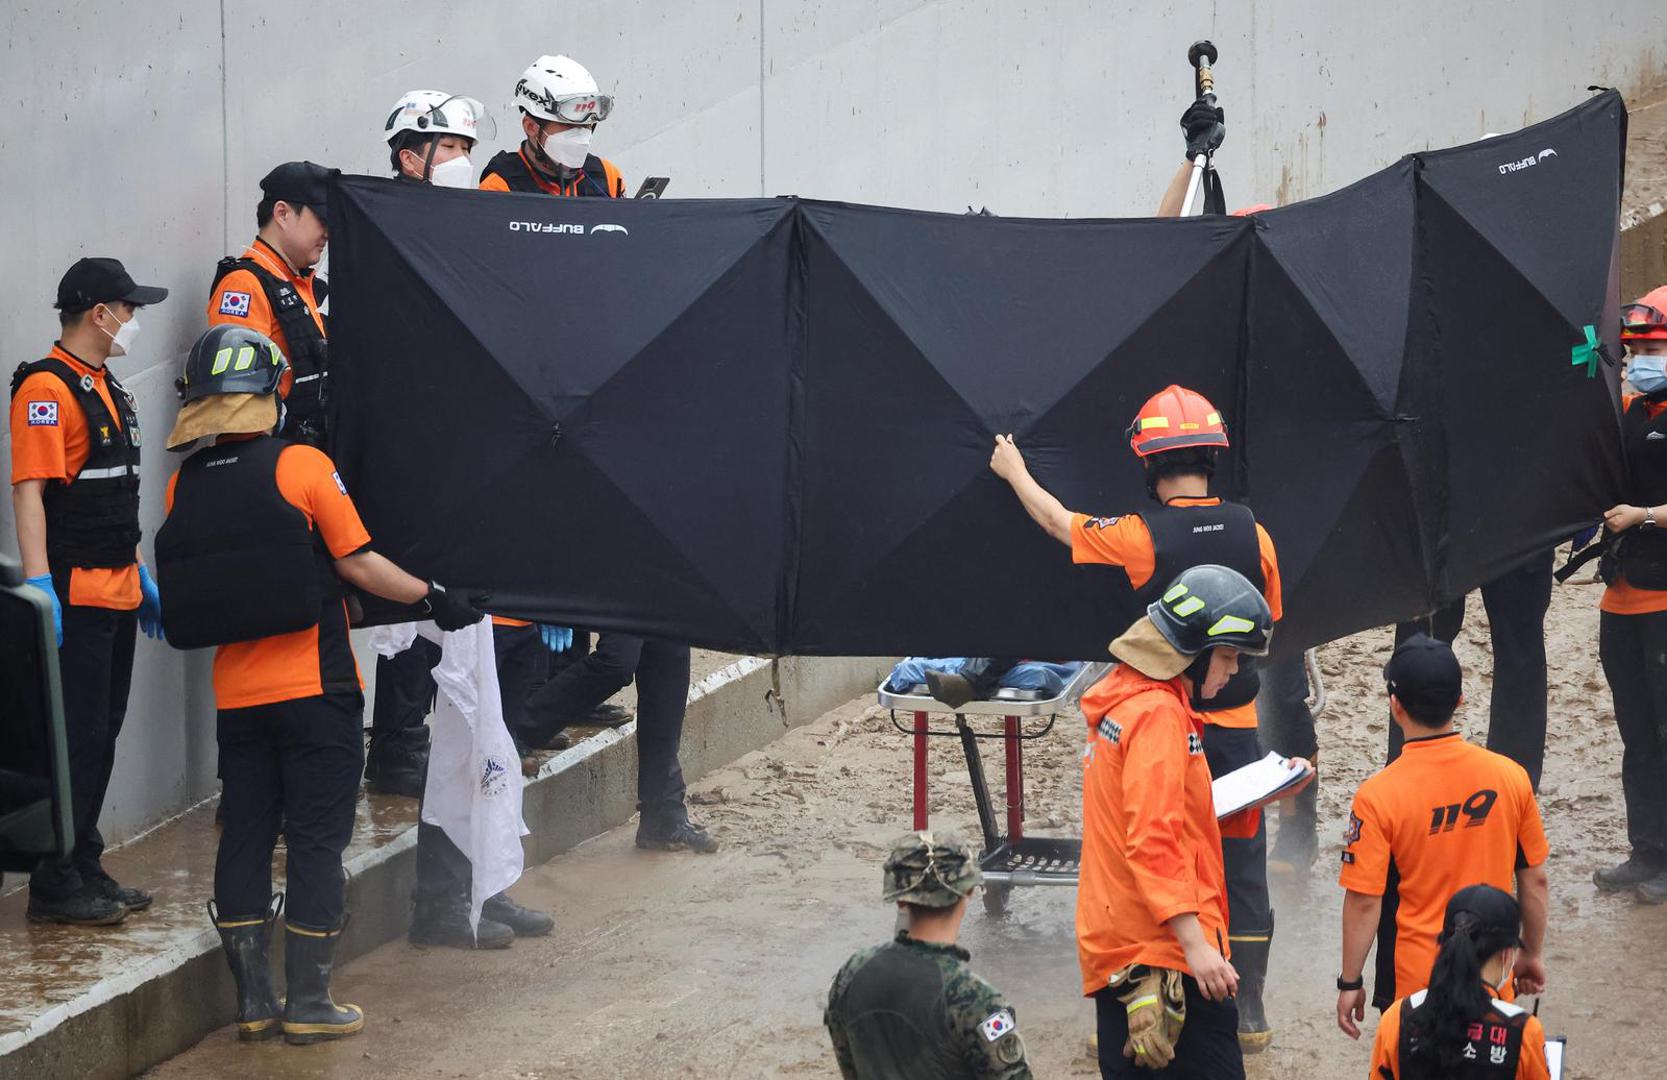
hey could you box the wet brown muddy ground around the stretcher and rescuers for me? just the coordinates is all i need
[152,566,1667,1080]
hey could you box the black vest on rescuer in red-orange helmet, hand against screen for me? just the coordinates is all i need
[1139,502,1267,713]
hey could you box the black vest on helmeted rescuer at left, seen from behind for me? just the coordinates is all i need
[157,435,347,653]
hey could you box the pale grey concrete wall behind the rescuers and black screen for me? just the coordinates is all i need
[0,0,1667,840]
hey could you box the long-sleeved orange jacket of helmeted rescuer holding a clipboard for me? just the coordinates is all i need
[1077,663,1227,995]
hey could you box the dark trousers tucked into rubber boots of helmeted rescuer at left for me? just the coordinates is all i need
[213,693,365,930]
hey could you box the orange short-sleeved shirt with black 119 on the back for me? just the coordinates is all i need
[1337,732,1550,997]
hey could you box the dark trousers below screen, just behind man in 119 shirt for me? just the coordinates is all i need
[1387,552,1554,790]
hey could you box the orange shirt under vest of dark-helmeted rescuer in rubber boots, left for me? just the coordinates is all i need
[167,443,370,708]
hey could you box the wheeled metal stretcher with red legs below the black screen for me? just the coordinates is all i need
[879,663,1112,915]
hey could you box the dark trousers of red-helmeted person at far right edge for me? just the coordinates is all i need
[1597,612,1667,863]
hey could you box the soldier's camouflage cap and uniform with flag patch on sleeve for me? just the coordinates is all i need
[822,833,1030,1080]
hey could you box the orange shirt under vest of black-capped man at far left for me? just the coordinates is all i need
[12,342,140,612]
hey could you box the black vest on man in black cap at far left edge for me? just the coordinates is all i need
[12,357,140,575]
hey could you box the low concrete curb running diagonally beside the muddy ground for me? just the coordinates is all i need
[0,657,890,1080]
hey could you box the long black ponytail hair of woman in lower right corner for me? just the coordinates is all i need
[1402,890,1522,1080]
